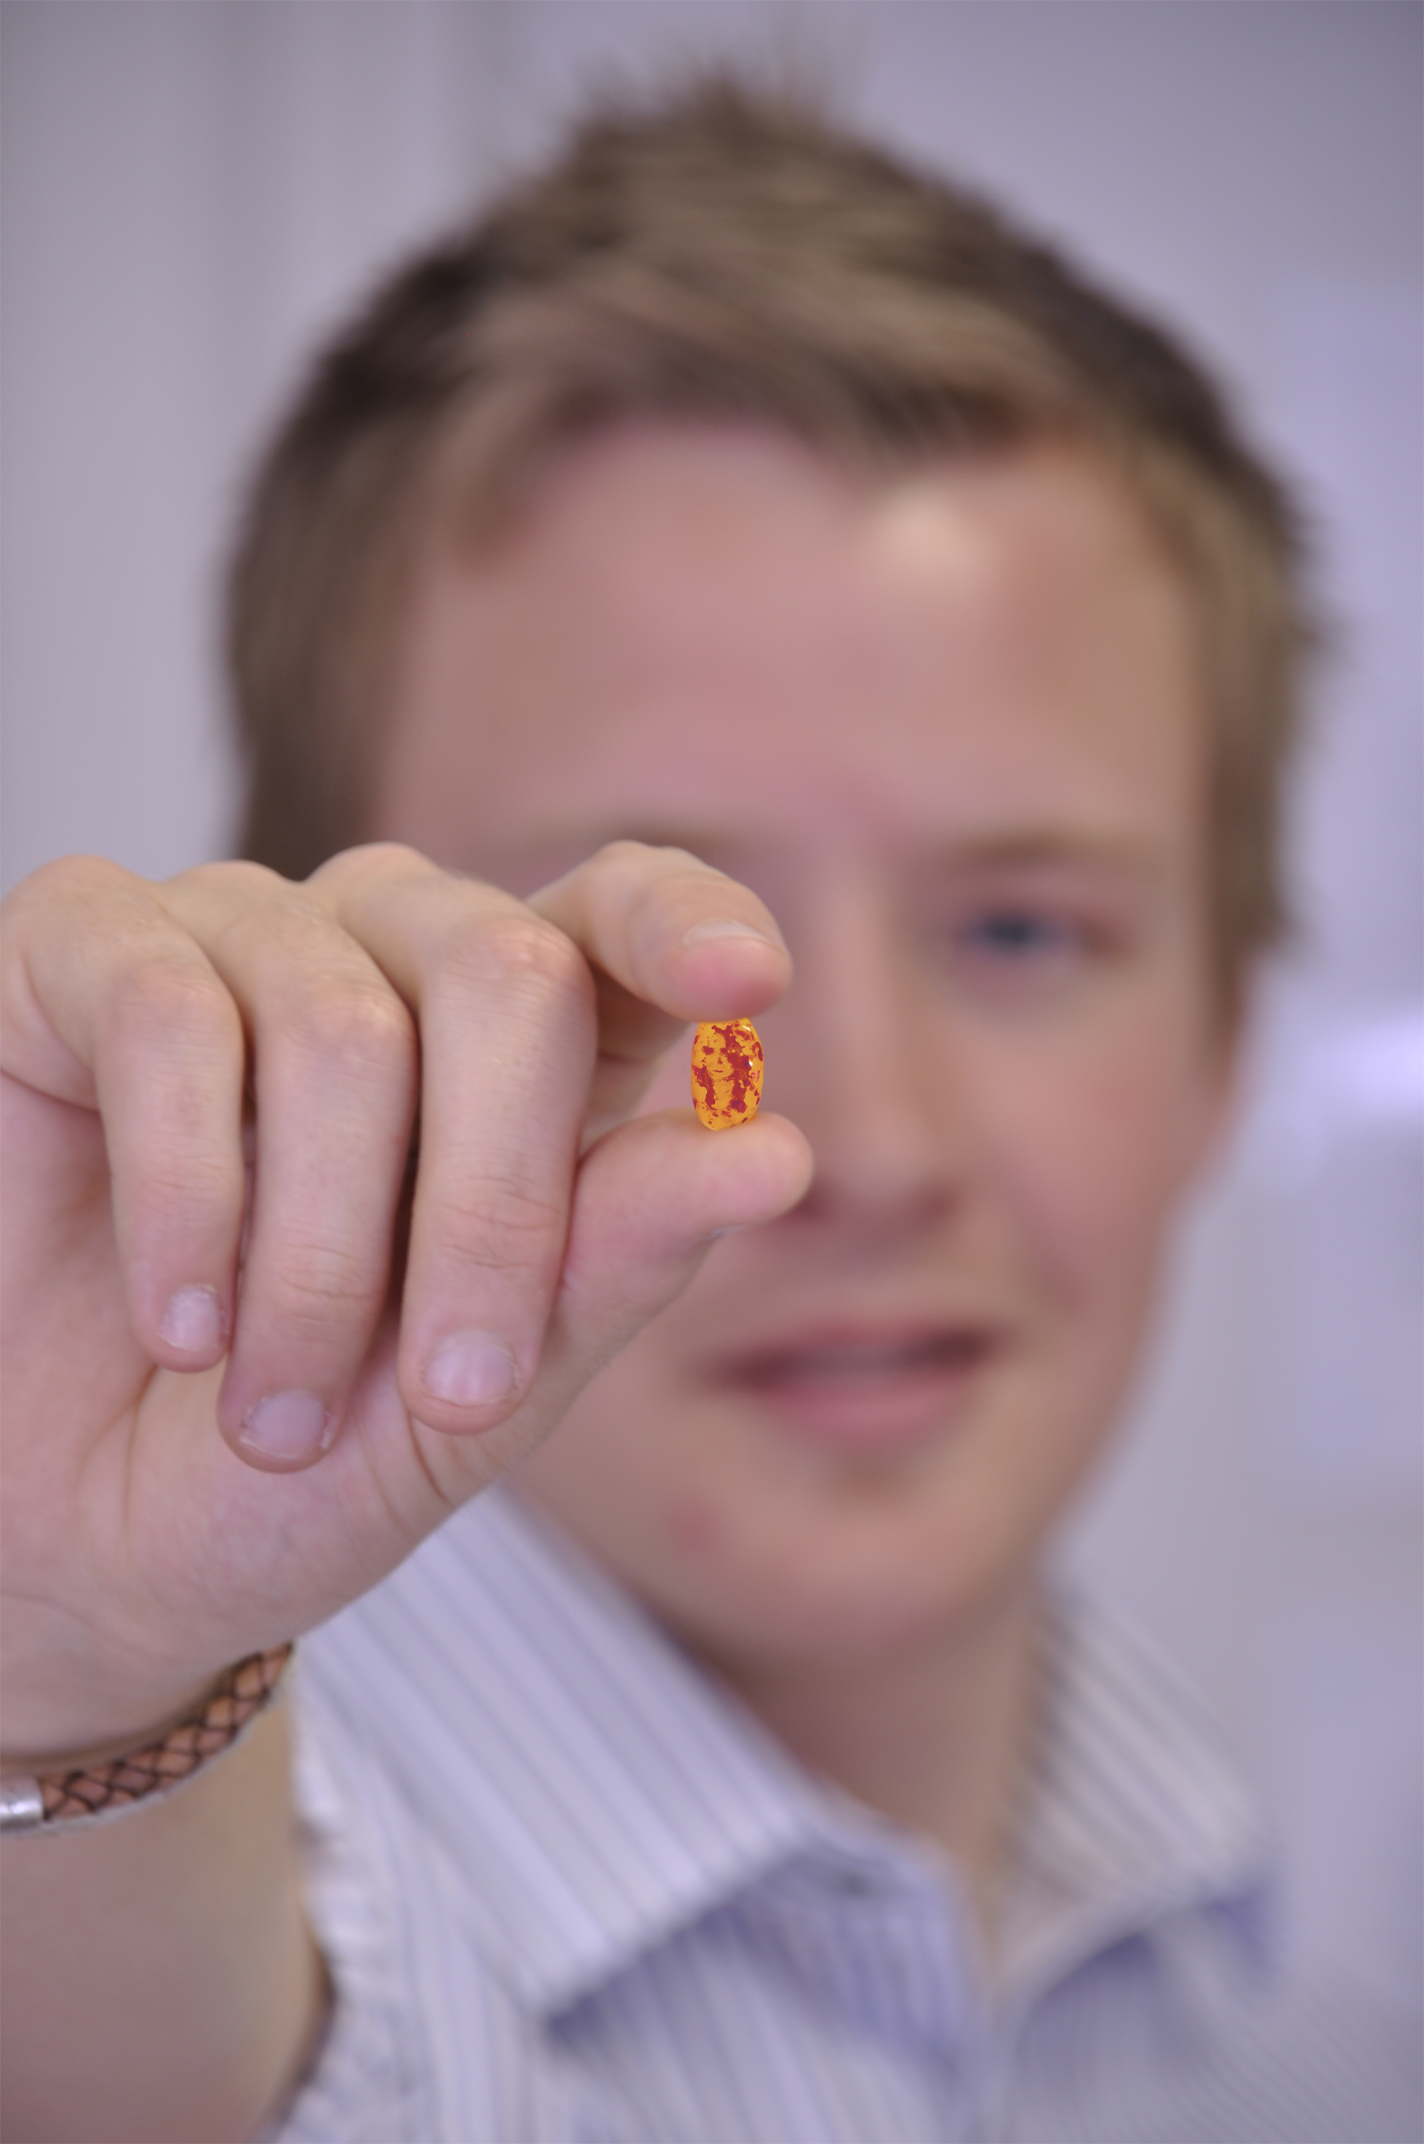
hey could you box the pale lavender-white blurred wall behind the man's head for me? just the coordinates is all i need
[0,0,1424,2005]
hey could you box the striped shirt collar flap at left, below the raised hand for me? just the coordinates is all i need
[307,1490,826,2013]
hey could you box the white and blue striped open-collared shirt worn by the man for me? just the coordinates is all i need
[272,1490,1418,2144]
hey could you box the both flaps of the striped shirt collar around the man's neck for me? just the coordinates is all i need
[307,1490,1259,2015]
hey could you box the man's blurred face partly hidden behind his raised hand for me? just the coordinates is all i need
[380,427,1227,1668]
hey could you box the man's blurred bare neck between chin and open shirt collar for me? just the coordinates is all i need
[716,1589,1038,1949]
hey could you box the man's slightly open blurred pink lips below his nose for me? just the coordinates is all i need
[723,1325,1006,1451]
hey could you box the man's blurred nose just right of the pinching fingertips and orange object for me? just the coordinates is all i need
[759,862,974,1233]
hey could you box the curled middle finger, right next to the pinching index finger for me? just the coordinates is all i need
[311,847,596,1432]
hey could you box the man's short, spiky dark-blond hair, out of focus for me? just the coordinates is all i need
[229,79,1310,1008]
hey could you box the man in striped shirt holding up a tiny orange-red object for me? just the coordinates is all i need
[4,86,1403,2144]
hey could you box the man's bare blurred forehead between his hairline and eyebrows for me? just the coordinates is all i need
[380,427,1201,870]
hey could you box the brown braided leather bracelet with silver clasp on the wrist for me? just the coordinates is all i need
[0,1644,294,1835]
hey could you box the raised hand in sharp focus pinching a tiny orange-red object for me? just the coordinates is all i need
[0,843,811,1758]
